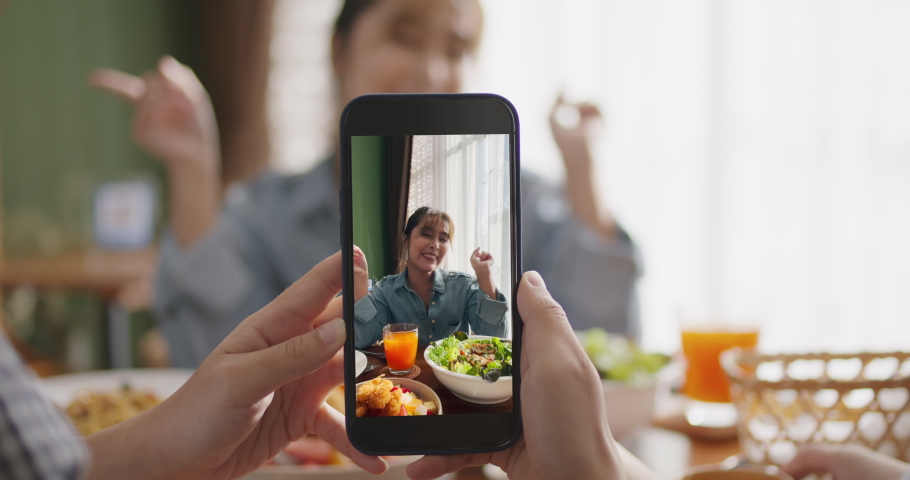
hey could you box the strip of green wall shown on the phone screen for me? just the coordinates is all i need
[351,137,395,279]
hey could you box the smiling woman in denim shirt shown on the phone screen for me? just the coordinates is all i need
[354,207,509,348]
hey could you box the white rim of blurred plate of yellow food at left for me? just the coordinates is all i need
[39,368,193,407]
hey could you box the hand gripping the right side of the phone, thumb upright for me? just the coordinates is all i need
[407,272,626,480]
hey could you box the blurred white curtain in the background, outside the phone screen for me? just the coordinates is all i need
[273,0,910,351]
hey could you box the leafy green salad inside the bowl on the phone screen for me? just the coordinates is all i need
[428,332,512,383]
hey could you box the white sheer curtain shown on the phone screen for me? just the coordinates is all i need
[408,135,512,337]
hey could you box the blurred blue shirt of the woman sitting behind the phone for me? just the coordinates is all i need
[154,160,641,368]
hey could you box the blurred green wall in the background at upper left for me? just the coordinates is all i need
[0,0,198,255]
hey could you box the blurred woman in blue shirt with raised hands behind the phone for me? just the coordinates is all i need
[92,0,639,368]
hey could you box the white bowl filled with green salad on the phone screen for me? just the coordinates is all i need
[423,332,512,404]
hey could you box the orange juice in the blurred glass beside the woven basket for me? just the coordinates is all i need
[682,327,758,403]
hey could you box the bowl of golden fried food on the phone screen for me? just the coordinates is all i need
[356,375,442,417]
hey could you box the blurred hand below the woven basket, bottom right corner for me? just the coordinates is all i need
[783,443,910,480]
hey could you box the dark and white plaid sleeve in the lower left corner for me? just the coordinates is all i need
[0,332,89,480]
